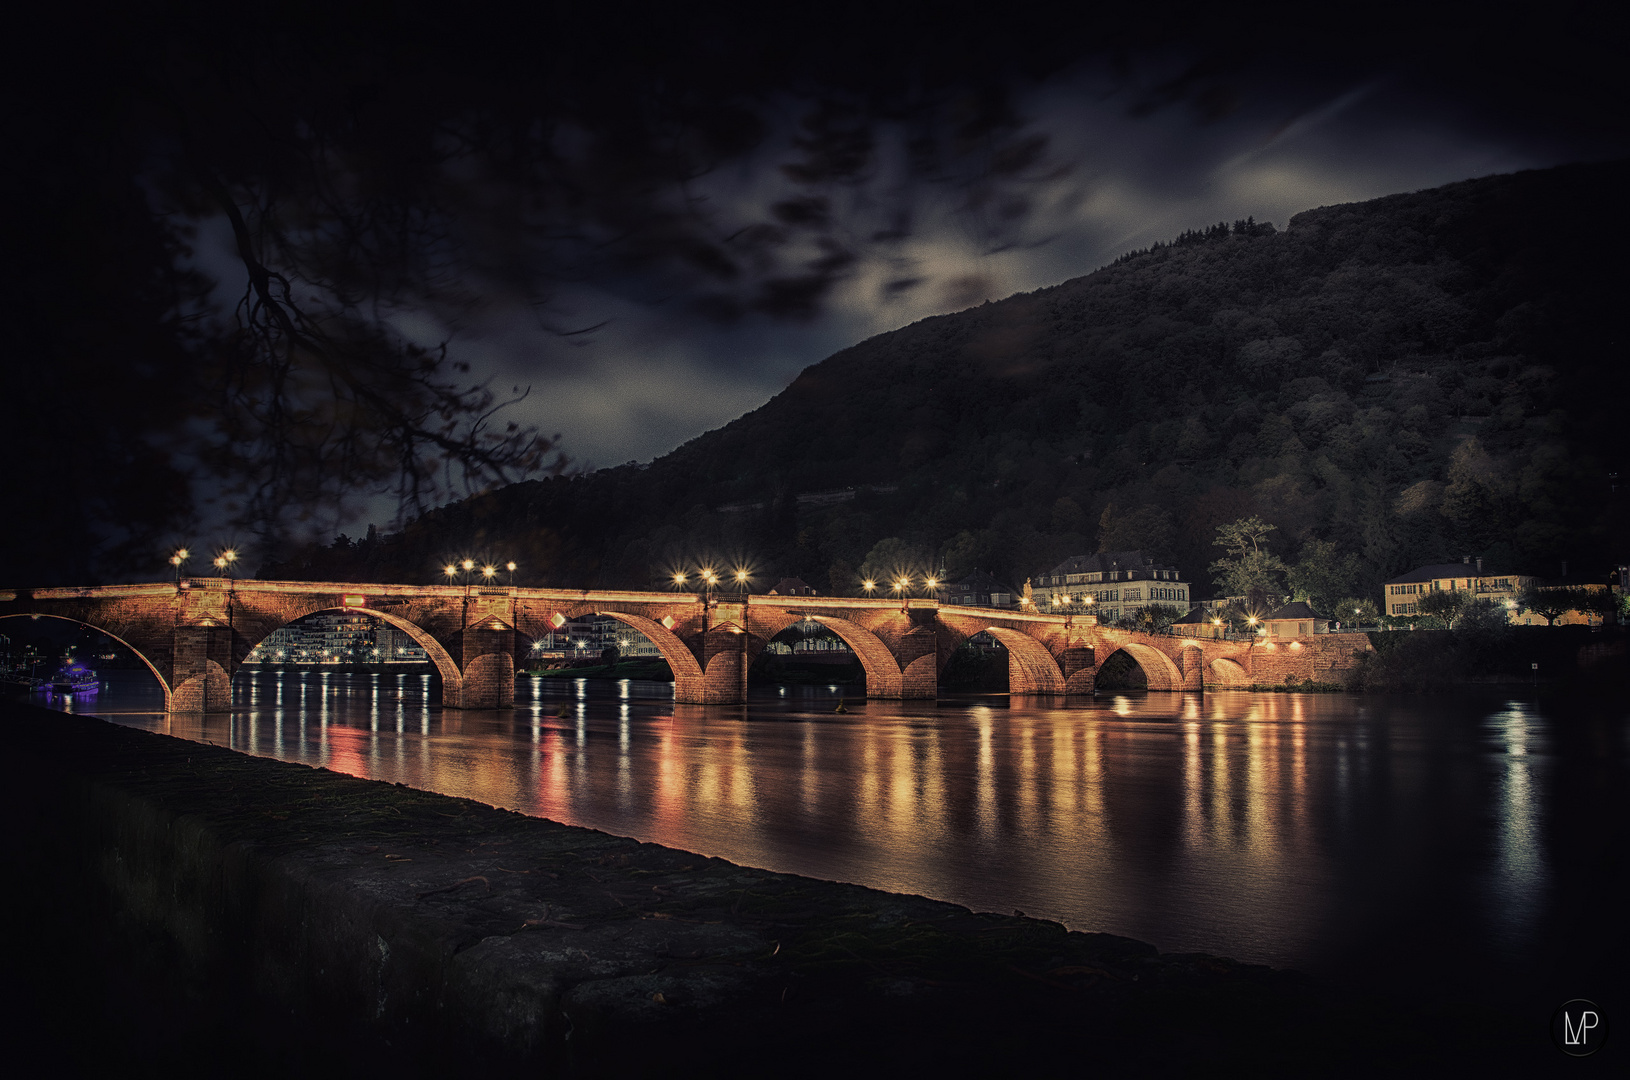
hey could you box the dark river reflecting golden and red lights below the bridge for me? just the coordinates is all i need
[36,671,1630,1015]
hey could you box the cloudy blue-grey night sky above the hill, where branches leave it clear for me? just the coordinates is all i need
[171,5,1630,478]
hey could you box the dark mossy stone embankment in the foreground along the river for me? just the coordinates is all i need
[0,705,1549,1075]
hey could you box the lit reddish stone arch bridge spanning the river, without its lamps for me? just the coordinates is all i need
[0,578,1371,712]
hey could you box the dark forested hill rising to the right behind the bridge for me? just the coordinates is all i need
[262,163,1630,609]
